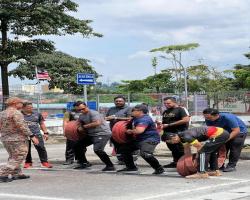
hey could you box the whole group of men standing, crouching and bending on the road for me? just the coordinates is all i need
[0,96,247,182]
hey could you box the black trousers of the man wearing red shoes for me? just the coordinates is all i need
[25,134,48,163]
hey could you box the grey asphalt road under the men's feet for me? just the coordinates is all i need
[0,144,250,200]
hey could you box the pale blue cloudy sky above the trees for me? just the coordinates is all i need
[7,0,250,84]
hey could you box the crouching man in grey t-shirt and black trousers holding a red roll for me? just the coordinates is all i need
[75,102,115,171]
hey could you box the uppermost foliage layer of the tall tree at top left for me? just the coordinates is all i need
[0,0,101,37]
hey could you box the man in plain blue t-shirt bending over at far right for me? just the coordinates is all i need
[203,108,247,172]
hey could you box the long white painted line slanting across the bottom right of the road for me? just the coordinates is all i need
[135,180,250,200]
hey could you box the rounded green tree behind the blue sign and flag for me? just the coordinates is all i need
[10,52,98,94]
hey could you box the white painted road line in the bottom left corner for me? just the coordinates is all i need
[0,193,76,200]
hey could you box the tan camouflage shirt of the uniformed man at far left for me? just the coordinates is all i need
[0,107,32,141]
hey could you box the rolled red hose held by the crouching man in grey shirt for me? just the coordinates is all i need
[64,121,85,141]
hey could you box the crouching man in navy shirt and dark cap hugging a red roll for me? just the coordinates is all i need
[118,105,164,174]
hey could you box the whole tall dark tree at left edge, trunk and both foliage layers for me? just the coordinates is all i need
[0,0,101,99]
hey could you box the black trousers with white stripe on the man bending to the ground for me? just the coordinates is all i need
[198,130,229,172]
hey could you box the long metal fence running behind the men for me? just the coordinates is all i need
[0,91,250,115]
